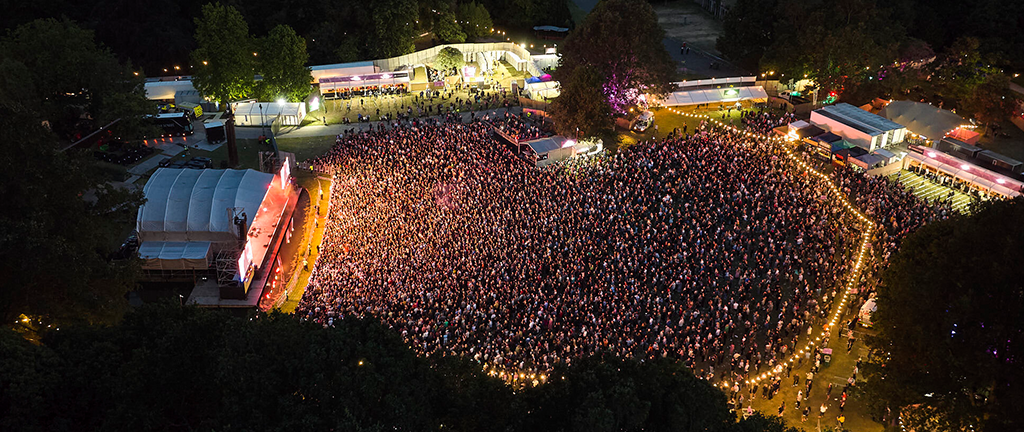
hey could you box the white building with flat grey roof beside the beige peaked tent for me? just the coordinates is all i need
[811,103,906,152]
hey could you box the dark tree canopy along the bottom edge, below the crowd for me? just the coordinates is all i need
[0,305,815,432]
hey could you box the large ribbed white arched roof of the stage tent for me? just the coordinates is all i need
[135,168,273,242]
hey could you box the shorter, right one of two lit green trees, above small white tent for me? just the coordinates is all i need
[256,26,312,102]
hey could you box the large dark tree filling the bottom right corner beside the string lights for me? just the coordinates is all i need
[864,198,1024,431]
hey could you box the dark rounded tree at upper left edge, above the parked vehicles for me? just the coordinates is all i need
[0,19,154,140]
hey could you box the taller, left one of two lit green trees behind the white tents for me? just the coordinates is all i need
[191,3,258,105]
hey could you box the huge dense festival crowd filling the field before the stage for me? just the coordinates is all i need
[299,114,872,384]
